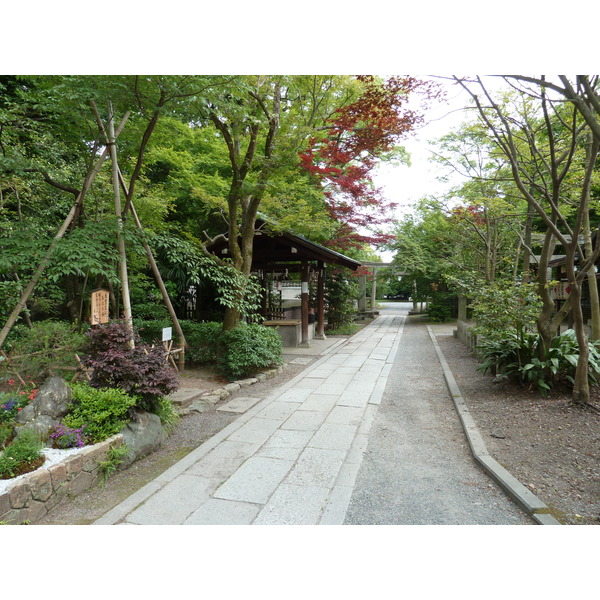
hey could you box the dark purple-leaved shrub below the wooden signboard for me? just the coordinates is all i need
[83,321,178,410]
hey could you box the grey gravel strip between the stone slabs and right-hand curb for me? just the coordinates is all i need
[345,318,532,525]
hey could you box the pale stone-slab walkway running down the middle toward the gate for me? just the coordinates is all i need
[95,304,532,525]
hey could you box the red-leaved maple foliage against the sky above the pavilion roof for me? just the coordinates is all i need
[300,75,437,249]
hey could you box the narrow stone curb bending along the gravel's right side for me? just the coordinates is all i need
[427,325,561,525]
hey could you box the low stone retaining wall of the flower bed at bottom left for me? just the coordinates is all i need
[0,433,123,525]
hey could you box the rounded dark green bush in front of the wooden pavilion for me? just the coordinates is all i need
[218,324,283,380]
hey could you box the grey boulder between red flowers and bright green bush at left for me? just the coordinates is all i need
[15,377,72,439]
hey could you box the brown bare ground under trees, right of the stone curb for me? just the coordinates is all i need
[434,328,600,525]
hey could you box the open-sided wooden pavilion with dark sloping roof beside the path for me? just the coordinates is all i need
[208,219,361,346]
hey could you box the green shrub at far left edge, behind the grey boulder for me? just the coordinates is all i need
[0,321,85,381]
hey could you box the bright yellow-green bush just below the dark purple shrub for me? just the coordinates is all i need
[62,383,140,444]
